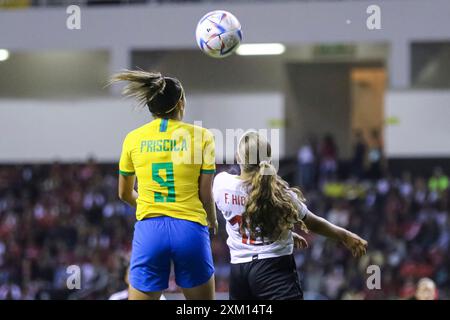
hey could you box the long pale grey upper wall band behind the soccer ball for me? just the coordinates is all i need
[0,0,450,50]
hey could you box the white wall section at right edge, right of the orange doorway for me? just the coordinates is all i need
[385,90,450,158]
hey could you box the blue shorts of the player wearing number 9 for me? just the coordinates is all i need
[129,216,214,292]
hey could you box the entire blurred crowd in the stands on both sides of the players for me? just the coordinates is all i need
[0,151,450,300]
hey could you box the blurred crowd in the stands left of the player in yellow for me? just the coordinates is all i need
[0,161,135,300]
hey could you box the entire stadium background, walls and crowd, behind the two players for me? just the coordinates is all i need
[0,0,450,299]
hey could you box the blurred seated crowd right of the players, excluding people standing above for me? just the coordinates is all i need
[297,170,450,299]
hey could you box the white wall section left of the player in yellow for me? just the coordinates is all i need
[0,100,148,162]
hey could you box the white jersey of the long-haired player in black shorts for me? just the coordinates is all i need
[213,172,308,264]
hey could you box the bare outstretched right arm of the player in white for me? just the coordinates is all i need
[303,211,367,257]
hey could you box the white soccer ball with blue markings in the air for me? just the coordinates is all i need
[195,10,242,58]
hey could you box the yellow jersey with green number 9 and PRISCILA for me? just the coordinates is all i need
[119,118,216,226]
